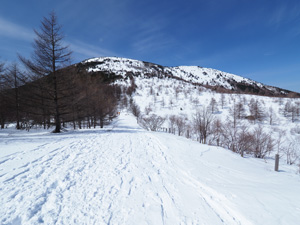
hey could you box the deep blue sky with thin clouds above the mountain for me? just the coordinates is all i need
[0,0,300,92]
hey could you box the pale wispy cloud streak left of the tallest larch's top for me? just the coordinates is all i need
[0,17,34,41]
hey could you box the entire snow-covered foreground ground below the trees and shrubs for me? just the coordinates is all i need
[0,113,300,225]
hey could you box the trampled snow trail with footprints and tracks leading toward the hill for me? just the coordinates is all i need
[0,116,298,225]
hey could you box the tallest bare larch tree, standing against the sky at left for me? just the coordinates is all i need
[19,12,72,133]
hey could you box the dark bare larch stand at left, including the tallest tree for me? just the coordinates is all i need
[0,12,121,133]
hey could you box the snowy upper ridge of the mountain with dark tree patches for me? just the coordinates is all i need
[75,57,300,96]
